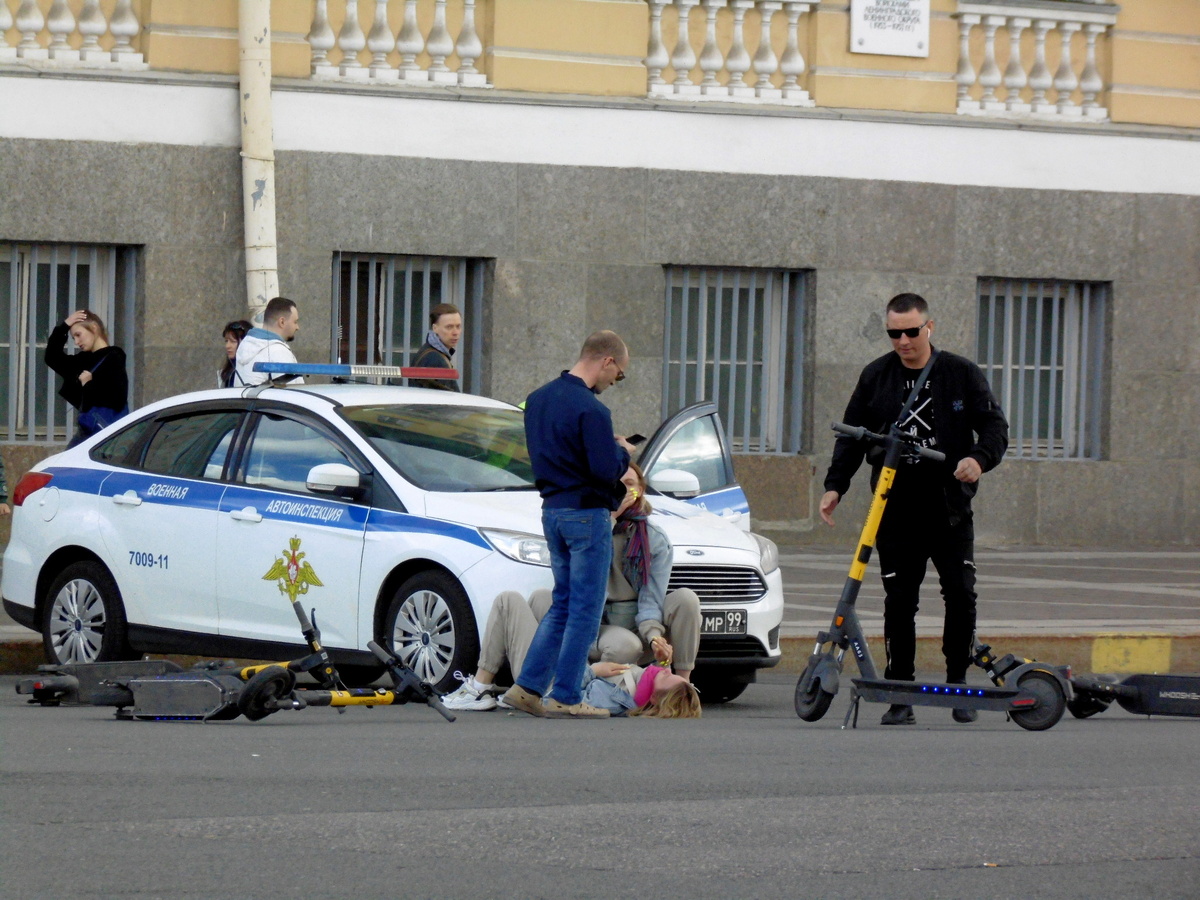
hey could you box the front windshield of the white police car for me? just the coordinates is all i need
[342,403,534,492]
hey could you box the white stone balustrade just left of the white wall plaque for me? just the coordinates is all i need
[646,0,815,107]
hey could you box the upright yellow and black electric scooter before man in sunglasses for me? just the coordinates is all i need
[796,403,1070,731]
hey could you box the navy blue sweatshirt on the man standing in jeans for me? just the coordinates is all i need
[526,371,629,509]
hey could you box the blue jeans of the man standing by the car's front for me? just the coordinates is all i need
[516,509,612,706]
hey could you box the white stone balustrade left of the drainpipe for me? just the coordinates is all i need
[0,0,146,68]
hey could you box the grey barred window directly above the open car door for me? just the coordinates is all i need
[662,266,806,454]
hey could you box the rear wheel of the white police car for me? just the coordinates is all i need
[42,560,134,665]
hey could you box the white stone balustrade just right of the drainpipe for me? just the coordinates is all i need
[308,0,491,88]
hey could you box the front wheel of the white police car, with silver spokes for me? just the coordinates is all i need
[384,571,479,691]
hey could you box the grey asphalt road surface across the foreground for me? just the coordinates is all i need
[0,672,1200,900]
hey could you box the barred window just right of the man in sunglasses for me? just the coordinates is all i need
[976,278,1110,460]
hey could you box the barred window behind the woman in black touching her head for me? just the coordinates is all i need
[0,242,137,443]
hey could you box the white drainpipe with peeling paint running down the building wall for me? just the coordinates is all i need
[238,0,280,325]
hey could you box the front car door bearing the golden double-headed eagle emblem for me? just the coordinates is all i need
[216,408,370,648]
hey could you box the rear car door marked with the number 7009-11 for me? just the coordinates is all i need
[98,407,244,635]
